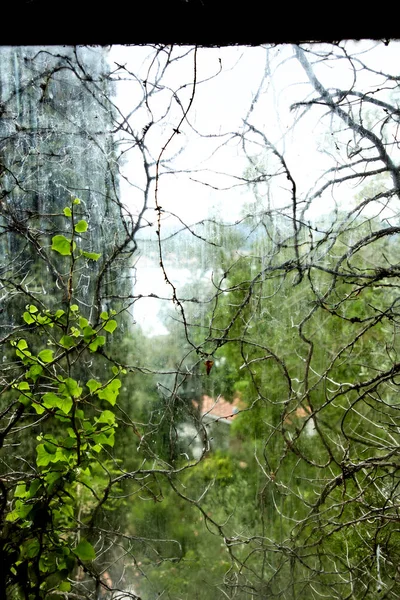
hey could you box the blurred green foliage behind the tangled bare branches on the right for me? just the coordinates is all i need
[137,209,400,600]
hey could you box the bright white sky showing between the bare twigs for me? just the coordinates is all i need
[109,41,400,335]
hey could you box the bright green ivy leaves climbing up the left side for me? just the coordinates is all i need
[2,200,123,599]
